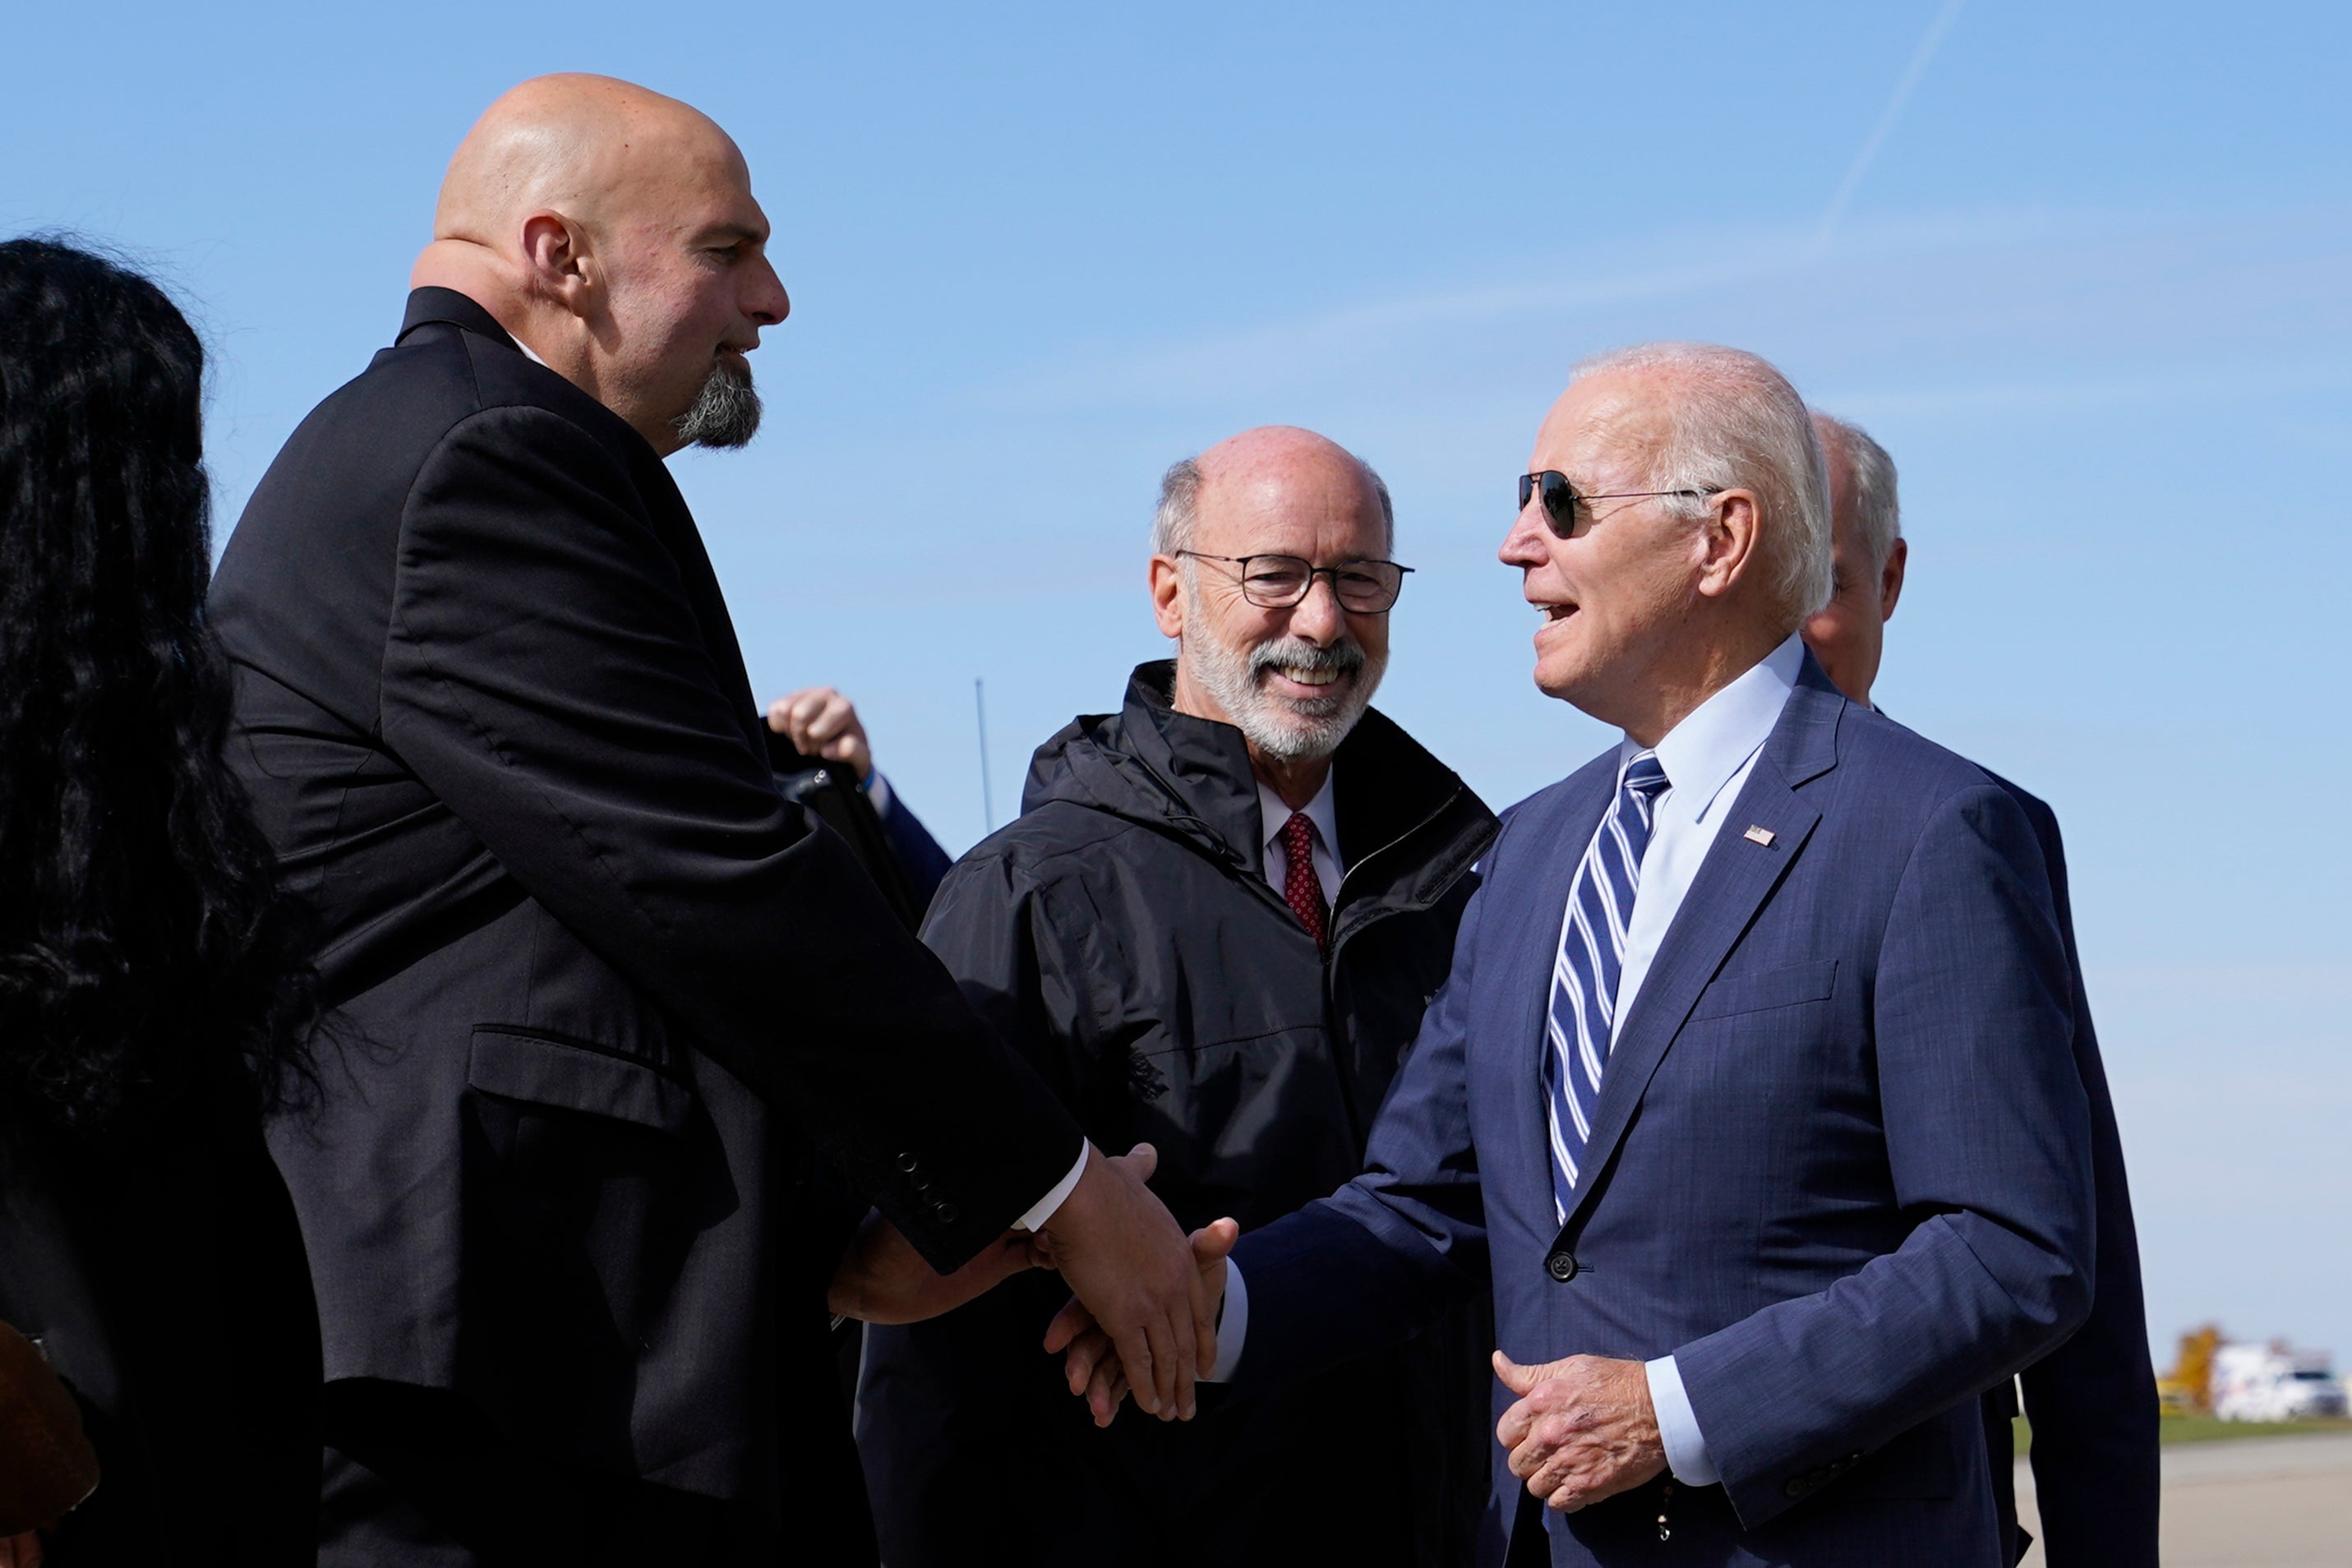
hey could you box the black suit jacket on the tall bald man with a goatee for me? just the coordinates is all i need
[212,289,1080,1526]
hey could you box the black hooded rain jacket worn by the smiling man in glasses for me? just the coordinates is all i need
[859,663,1496,1568]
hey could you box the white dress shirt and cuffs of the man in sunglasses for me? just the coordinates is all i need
[1211,632,1804,1486]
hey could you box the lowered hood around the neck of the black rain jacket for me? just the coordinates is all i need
[1021,658,1493,921]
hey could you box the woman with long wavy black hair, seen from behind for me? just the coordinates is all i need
[0,240,320,1568]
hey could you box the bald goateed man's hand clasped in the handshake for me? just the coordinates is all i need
[1045,1142,1216,1420]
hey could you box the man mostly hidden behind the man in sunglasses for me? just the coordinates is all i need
[1804,412,2161,1568]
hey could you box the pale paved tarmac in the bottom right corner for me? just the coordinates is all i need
[2018,1432,2352,1568]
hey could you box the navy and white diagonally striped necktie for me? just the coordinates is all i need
[1543,752,1667,1222]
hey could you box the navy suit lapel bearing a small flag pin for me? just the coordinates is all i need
[1561,653,1847,1224]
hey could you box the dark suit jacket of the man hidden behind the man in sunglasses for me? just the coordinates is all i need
[1985,776,2161,1568]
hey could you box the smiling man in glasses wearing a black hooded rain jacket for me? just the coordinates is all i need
[859,428,1496,1568]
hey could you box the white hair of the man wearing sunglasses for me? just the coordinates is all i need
[1569,344,1832,628]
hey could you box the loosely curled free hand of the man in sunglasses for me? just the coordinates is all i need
[1493,1352,1665,1514]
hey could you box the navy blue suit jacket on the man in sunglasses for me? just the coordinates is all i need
[1237,658,2093,1568]
